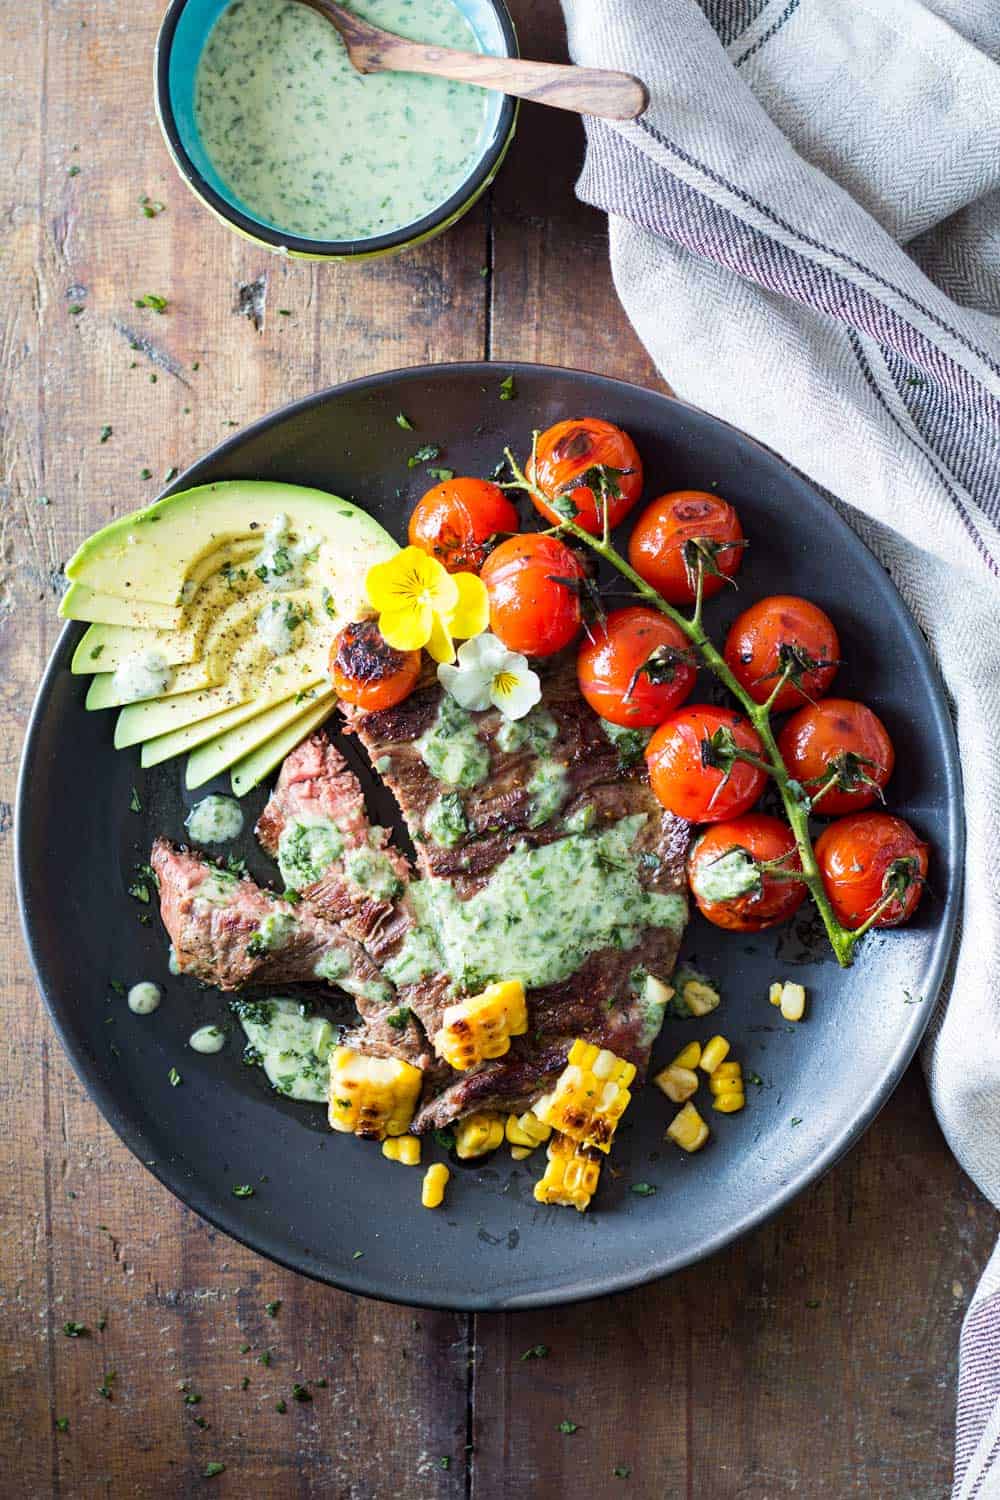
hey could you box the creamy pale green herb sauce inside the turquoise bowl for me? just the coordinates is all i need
[195,0,487,240]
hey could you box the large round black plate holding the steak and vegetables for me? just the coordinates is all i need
[16,365,963,1308]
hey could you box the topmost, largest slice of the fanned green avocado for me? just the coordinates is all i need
[66,480,397,624]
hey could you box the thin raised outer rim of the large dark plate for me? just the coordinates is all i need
[13,360,966,1313]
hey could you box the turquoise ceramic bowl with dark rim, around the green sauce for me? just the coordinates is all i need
[156,0,517,261]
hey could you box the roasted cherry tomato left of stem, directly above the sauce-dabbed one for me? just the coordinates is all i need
[646,704,768,824]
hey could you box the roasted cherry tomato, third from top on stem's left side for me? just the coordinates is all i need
[576,605,697,728]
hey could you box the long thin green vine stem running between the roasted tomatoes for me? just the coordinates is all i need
[502,432,863,969]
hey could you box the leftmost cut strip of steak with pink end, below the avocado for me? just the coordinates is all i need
[150,839,432,1067]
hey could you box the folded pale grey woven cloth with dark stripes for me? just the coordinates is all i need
[562,0,1000,1500]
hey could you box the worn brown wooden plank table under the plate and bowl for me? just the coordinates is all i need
[0,0,996,1500]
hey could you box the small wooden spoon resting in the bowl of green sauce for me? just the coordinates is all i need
[301,0,649,120]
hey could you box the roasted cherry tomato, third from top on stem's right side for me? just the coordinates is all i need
[724,594,840,714]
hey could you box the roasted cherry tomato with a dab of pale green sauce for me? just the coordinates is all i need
[688,813,805,933]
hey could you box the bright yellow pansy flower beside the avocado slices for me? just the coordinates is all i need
[364,548,490,662]
